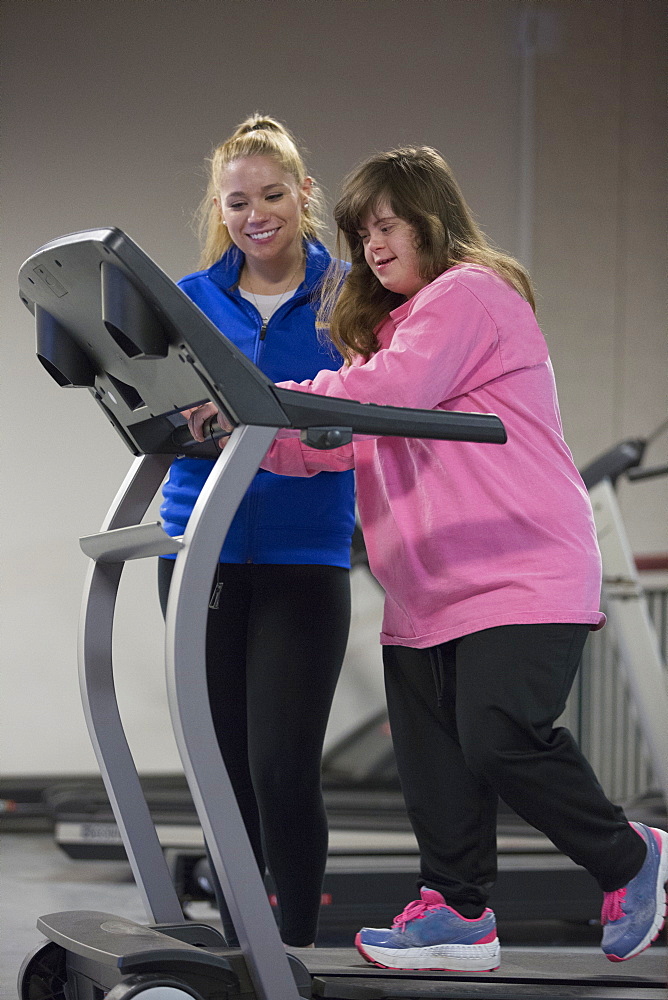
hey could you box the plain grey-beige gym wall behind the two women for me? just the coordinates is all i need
[0,0,668,774]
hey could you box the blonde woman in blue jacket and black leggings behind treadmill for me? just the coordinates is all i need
[159,115,354,947]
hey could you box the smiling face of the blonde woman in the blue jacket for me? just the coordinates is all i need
[215,156,313,262]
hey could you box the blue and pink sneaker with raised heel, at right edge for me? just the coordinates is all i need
[601,823,668,962]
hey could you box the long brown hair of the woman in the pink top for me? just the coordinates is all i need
[318,146,535,363]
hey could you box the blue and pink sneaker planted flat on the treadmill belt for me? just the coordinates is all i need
[355,887,501,972]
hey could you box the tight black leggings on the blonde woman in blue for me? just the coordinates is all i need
[158,559,350,947]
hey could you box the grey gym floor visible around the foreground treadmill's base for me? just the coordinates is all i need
[0,831,668,1000]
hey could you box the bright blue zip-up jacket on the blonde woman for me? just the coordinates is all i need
[160,242,355,567]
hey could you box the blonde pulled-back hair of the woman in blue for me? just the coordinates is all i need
[196,112,326,269]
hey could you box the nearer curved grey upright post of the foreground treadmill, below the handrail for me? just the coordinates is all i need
[165,425,299,1000]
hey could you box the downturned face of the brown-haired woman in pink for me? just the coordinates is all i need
[358,200,429,298]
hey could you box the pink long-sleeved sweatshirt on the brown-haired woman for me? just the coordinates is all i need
[263,264,605,648]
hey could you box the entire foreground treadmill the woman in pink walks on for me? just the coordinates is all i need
[19,228,668,1000]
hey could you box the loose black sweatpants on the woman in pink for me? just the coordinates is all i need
[383,625,646,917]
